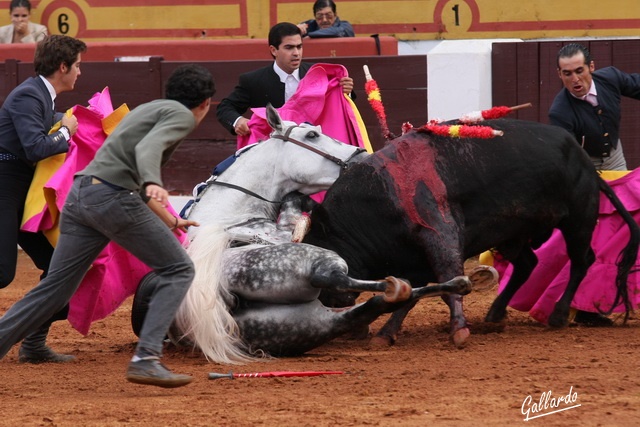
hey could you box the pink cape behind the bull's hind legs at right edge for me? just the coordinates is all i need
[495,169,640,324]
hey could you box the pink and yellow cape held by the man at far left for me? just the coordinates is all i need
[22,88,184,335]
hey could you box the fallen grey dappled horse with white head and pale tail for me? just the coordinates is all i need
[132,108,494,363]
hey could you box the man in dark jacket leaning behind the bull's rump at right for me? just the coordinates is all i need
[549,43,640,170]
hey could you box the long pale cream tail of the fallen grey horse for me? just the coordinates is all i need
[176,224,257,364]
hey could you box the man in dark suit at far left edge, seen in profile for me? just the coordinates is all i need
[0,35,87,363]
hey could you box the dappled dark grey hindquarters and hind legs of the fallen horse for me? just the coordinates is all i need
[134,243,497,363]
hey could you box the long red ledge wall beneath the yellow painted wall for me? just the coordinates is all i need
[0,37,398,62]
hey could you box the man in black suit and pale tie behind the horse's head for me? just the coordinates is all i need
[216,22,353,135]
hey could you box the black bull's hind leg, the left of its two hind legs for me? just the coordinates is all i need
[484,246,538,323]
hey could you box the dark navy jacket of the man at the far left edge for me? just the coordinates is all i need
[0,77,69,165]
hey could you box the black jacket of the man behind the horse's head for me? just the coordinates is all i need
[216,62,313,135]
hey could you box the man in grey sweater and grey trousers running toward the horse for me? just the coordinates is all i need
[0,65,215,387]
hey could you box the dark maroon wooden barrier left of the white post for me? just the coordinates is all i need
[0,55,427,194]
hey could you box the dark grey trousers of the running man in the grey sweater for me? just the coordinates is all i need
[0,176,194,359]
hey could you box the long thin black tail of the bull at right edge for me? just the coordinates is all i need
[600,178,640,323]
